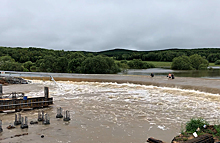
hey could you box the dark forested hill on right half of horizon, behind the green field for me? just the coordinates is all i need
[98,48,220,62]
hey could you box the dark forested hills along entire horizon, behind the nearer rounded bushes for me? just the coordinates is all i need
[0,47,220,63]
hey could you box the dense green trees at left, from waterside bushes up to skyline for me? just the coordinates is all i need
[0,47,154,74]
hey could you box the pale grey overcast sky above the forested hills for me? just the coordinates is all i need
[0,0,220,52]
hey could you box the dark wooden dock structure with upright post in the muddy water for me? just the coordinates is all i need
[0,85,53,112]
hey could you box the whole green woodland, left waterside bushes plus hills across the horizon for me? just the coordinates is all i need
[0,47,220,74]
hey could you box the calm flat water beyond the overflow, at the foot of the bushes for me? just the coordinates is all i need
[5,67,220,79]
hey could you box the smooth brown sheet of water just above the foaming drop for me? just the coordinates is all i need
[23,74,220,94]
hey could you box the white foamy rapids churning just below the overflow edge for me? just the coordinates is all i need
[31,80,220,126]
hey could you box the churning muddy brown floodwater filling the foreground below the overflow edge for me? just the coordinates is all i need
[0,80,220,143]
